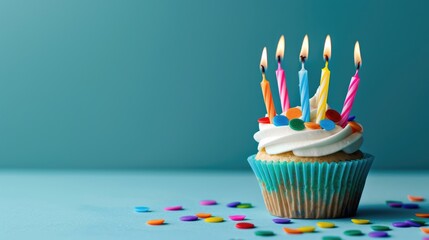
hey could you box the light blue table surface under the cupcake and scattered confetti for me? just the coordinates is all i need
[0,170,429,240]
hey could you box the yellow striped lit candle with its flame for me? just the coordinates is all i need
[316,35,331,122]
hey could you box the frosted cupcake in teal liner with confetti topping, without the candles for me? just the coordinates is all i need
[248,36,374,219]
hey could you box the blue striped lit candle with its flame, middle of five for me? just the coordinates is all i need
[298,35,310,122]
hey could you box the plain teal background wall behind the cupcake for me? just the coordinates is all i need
[0,0,429,169]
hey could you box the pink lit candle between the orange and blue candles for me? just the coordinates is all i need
[276,35,290,113]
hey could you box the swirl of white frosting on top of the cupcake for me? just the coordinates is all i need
[254,89,363,157]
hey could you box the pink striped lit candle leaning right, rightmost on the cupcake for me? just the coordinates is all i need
[338,42,362,127]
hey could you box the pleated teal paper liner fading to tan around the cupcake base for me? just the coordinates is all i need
[247,154,374,219]
